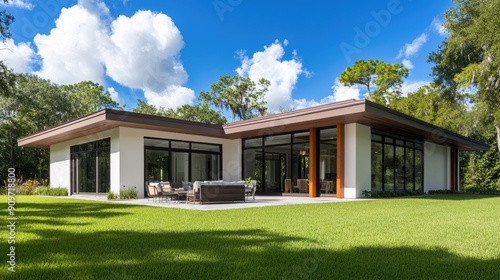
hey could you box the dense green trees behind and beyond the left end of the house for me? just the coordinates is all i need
[0,74,120,178]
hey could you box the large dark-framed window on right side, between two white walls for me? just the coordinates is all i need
[371,133,423,191]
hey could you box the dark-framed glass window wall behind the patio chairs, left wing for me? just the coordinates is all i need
[144,138,222,190]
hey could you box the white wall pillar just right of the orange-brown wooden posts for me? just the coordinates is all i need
[344,123,371,198]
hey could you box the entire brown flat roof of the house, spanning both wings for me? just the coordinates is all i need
[18,99,489,151]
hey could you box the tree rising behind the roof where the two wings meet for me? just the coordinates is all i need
[198,76,271,121]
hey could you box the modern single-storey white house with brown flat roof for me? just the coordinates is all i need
[18,100,489,198]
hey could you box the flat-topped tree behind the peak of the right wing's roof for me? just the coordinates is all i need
[339,59,408,106]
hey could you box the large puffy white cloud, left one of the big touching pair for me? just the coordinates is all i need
[34,5,109,84]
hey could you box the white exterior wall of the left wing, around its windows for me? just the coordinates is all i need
[50,127,242,197]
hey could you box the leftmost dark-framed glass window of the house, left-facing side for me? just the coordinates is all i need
[70,138,111,193]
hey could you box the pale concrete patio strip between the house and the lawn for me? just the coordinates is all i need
[65,194,364,211]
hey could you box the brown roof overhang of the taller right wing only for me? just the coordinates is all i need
[224,100,490,151]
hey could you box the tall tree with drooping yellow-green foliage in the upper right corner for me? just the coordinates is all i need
[429,0,500,150]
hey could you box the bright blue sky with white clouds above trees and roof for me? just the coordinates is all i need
[0,0,451,110]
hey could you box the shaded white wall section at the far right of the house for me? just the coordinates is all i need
[424,142,451,192]
